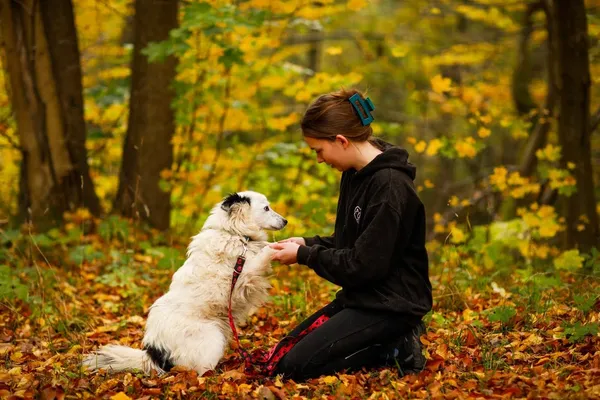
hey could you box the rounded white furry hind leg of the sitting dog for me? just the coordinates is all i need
[173,321,227,375]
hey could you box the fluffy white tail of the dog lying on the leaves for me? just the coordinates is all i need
[82,344,164,374]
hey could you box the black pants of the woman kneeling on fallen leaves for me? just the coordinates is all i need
[276,301,420,381]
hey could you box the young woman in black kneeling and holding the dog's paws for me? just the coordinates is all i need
[271,90,432,380]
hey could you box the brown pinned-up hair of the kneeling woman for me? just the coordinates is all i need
[300,89,373,142]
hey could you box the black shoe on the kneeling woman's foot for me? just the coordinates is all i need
[381,322,427,376]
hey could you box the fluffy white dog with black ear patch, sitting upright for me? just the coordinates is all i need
[83,191,287,375]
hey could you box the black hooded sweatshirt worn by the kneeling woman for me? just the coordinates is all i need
[298,139,432,318]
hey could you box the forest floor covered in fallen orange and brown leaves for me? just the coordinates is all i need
[0,225,600,400]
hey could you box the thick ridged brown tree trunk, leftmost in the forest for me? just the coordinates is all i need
[0,0,101,229]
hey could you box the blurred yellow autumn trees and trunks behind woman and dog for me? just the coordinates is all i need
[0,0,600,255]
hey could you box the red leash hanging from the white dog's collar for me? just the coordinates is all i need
[228,243,329,376]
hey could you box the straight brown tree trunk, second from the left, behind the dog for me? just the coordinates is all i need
[114,0,178,229]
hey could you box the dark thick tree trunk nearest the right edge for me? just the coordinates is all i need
[554,0,599,251]
